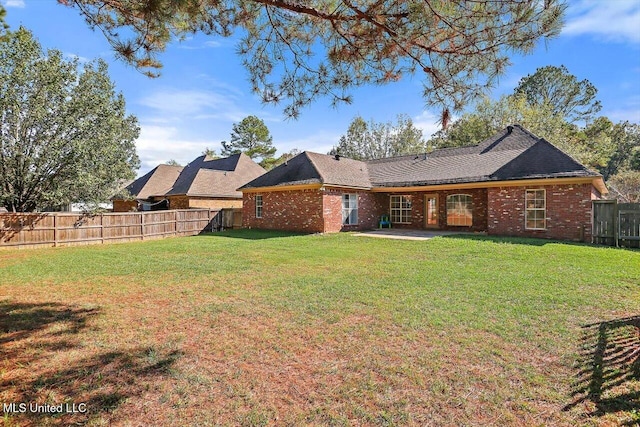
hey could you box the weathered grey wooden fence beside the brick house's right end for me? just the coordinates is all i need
[593,200,640,248]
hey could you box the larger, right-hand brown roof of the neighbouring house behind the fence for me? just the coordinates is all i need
[163,154,266,197]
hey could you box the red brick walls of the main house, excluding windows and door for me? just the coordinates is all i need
[243,184,593,241]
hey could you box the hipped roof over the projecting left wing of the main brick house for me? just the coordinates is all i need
[241,151,371,190]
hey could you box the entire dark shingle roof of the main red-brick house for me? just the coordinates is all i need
[241,125,600,189]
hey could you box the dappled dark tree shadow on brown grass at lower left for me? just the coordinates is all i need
[0,300,182,425]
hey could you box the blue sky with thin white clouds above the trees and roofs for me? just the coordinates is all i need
[0,0,640,175]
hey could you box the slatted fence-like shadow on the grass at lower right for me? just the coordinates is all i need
[564,316,640,425]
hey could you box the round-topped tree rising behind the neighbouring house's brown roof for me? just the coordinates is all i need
[221,116,276,165]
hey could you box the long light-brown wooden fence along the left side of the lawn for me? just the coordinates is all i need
[0,209,221,247]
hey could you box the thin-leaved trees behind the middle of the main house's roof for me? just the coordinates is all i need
[329,115,426,160]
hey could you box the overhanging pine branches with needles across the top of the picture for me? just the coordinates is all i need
[58,0,566,117]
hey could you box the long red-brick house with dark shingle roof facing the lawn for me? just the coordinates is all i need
[240,125,607,241]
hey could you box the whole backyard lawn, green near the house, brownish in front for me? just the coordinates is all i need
[0,230,640,426]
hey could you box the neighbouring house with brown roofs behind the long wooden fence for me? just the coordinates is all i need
[113,154,266,212]
